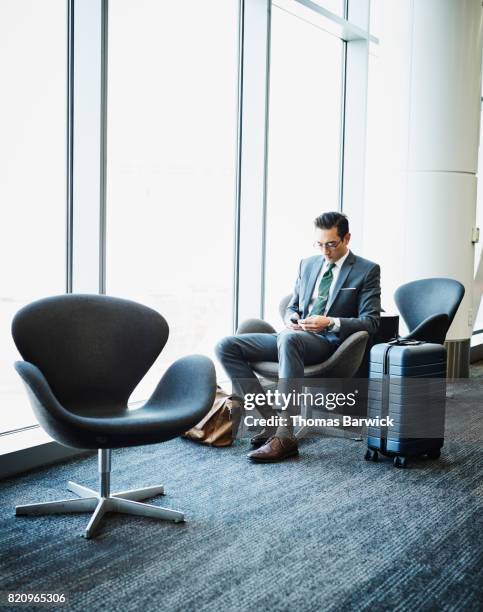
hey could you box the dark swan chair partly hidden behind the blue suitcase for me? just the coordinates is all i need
[394,278,465,344]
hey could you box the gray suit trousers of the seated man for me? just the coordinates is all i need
[215,329,337,418]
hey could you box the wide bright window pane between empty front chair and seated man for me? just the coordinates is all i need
[106,0,238,399]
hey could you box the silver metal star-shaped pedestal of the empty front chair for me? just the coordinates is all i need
[15,449,184,538]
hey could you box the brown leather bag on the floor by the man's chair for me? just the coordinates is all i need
[183,385,241,447]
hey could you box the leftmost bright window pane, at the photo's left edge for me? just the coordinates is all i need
[0,0,67,433]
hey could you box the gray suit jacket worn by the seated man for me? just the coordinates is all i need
[284,252,381,344]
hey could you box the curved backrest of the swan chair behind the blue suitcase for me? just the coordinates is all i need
[394,278,465,331]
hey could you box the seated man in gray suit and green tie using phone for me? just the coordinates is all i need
[216,212,381,462]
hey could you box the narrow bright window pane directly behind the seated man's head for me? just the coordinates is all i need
[265,5,344,326]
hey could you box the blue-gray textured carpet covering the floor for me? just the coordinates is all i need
[0,379,483,612]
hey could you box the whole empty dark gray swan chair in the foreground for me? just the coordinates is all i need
[12,295,216,538]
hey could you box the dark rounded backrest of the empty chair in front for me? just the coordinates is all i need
[12,294,169,408]
